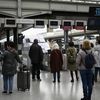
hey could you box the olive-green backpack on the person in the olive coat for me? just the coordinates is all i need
[67,48,76,64]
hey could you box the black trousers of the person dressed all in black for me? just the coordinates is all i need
[32,63,40,79]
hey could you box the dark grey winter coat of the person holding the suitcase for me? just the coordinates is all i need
[0,50,22,75]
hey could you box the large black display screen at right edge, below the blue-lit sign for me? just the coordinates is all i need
[87,18,100,30]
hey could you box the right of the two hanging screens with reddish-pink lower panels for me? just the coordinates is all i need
[74,20,87,30]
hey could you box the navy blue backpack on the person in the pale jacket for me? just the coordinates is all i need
[85,51,96,69]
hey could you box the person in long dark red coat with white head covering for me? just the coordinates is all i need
[50,43,63,83]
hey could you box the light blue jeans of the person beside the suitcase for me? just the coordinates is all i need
[3,75,14,92]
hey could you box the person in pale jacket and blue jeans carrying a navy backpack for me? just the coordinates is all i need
[76,40,93,100]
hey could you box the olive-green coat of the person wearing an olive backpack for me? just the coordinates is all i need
[67,47,77,71]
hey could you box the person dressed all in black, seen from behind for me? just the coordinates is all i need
[29,39,43,81]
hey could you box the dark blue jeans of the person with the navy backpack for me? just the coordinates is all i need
[80,69,93,100]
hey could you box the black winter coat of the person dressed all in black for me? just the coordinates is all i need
[29,43,43,64]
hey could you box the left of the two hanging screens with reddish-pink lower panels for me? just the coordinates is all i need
[62,20,74,30]
